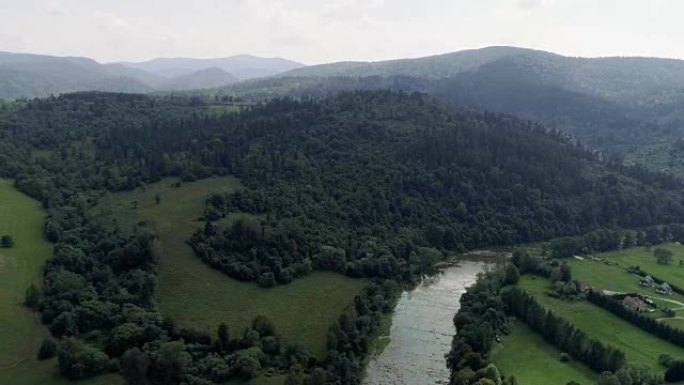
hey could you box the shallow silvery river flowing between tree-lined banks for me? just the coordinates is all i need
[363,260,494,385]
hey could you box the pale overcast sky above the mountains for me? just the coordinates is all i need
[0,0,684,64]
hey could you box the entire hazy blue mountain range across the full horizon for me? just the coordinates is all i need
[0,47,684,172]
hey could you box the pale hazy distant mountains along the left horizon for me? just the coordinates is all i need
[0,52,302,99]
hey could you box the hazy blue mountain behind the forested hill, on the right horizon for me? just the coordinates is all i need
[225,47,684,169]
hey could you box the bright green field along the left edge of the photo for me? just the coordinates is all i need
[0,180,122,385]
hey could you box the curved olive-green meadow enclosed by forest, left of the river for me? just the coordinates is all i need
[94,177,366,357]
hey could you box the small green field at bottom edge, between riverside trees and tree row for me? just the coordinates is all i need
[492,323,598,385]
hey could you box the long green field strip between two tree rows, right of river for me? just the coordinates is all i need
[518,276,684,371]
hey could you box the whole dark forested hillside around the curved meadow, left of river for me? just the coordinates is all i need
[0,91,684,384]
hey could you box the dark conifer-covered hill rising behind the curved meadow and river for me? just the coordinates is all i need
[6,92,684,249]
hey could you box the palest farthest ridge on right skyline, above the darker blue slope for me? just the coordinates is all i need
[279,46,684,103]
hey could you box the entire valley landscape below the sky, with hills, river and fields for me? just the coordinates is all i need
[0,41,684,385]
